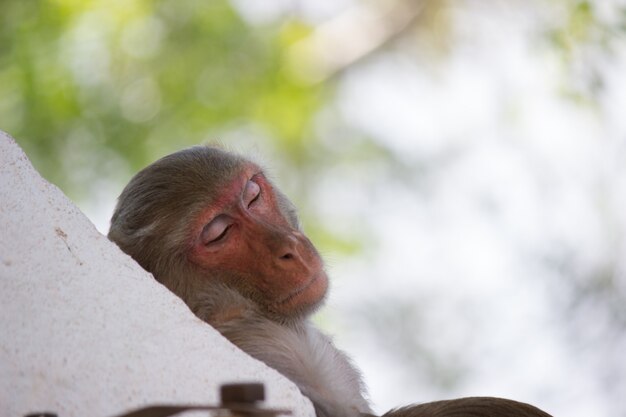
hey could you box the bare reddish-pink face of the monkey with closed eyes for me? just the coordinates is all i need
[189,165,328,314]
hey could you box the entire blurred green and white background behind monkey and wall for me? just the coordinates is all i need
[0,0,626,417]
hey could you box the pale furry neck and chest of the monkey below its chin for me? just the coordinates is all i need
[190,284,371,417]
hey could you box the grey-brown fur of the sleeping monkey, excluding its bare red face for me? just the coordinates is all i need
[109,147,548,417]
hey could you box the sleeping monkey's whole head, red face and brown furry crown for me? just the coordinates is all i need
[109,146,328,320]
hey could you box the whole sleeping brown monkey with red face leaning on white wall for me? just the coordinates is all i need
[108,146,548,417]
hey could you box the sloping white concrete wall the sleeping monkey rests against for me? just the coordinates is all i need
[0,132,314,417]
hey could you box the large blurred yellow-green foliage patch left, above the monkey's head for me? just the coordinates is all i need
[0,0,323,195]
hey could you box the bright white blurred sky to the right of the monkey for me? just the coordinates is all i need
[312,1,626,417]
